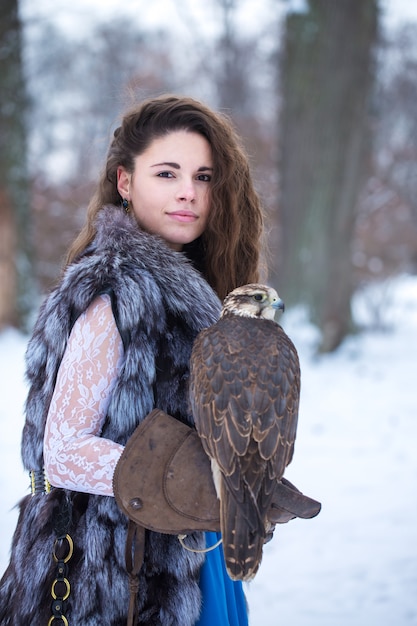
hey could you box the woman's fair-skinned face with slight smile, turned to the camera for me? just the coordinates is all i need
[117,130,213,250]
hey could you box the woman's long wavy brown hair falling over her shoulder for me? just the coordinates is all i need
[66,95,263,298]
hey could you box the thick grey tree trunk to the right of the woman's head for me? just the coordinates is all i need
[279,0,377,351]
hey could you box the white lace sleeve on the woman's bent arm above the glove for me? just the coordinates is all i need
[44,295,123,496]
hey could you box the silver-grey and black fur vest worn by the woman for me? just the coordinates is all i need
[0,206,220,626]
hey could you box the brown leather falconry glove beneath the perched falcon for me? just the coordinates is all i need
[113,409,321,535]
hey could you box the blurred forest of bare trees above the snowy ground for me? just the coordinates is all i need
[0,0,417,352]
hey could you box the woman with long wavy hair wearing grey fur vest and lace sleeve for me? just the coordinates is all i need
[0,96,262,626]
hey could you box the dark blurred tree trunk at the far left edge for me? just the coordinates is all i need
[0,0,35,328]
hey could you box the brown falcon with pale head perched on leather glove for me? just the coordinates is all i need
[190,284,300,580]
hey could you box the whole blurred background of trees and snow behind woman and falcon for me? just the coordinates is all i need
[0,0,417,626]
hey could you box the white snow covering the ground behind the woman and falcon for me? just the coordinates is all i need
[0,277,417,626]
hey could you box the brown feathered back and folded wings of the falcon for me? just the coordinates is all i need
[190,316,300,489]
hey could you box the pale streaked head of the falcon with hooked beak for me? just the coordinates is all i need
[221,283,284,320]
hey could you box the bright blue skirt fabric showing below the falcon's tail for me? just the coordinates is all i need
[196,533,248,626]
